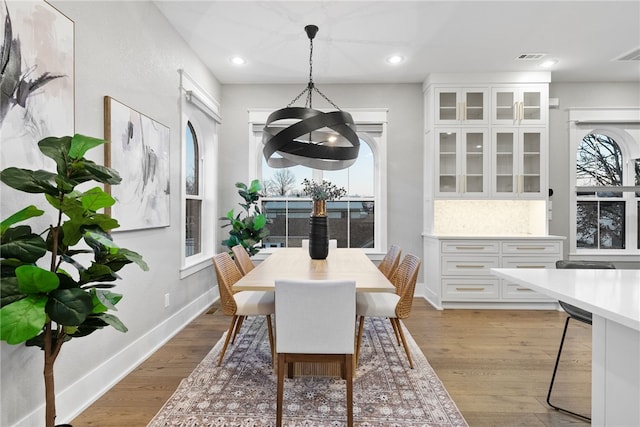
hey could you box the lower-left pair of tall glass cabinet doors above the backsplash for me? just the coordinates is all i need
[436,128,489,198]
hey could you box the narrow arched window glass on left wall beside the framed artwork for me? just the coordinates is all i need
[184,122,202,257]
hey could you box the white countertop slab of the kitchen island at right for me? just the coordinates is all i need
[491,268,640,331]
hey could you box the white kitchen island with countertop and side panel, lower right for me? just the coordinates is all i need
[491,268,640,427]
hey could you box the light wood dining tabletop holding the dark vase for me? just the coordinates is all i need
[233,248,395,292]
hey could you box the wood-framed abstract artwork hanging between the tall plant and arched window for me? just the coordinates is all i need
[104,96,170,231]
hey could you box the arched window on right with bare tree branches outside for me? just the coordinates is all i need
[572,110,640,255]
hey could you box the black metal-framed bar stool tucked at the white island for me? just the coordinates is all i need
[547,260,616,421]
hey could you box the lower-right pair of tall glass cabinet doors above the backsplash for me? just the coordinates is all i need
[491,128,546,199]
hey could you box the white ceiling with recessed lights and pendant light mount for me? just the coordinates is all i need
[155,0,640,84]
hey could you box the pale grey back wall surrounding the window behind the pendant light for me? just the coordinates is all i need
[219,83,424,257]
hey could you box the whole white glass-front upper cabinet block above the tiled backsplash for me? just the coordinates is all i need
[424,73,550,200]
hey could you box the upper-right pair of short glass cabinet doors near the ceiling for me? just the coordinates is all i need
[491,85,549,126]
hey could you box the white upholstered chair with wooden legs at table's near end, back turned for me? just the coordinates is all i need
[275,279,356,426]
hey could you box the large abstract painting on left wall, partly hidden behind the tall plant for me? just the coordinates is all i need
[0,1,75,169]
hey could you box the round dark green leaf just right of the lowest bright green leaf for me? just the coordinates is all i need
[45,288,93,326]
